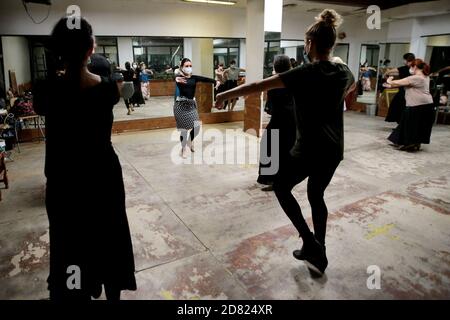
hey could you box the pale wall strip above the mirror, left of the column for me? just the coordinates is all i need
[0,0,246,38]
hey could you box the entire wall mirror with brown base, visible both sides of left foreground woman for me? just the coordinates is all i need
[0,36,246,132]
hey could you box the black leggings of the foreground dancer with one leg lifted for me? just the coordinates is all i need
[273,157,339,245]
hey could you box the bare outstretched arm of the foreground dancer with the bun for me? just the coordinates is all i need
[215,74,285,109]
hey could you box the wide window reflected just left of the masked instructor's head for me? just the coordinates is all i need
[133,37,183,72]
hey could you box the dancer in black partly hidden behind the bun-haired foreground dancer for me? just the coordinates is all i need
[257,55,296,191]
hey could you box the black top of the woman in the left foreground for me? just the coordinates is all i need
[33,77,120,178]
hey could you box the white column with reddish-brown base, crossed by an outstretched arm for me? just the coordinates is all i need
[244,0,264,136]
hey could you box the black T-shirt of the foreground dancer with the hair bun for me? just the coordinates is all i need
[280,61,355,161]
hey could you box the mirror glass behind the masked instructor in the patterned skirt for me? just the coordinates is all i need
[114,37,245,121]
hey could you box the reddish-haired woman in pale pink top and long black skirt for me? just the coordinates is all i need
[385,59,434,151]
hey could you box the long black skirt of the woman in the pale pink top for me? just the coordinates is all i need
[388,104,435,146]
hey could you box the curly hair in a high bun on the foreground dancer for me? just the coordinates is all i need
[305,9,342,54]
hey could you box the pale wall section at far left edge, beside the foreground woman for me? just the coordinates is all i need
[2,37,31,90]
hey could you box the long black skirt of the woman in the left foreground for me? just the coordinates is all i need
[46,151,136,300]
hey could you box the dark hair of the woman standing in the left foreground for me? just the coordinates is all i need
[50,17,94,78]
